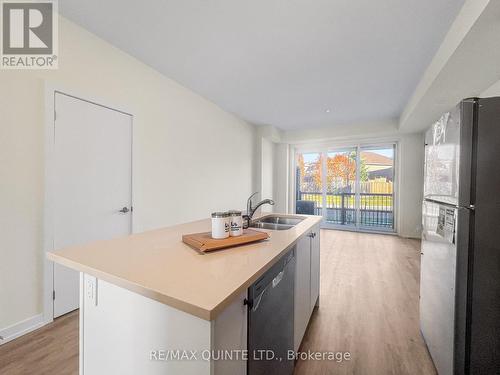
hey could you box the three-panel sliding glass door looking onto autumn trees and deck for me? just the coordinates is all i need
[295,144,396,231]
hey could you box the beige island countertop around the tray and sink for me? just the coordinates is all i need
[47,215,321,320]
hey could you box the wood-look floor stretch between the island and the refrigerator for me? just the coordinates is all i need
[295,230,436,375]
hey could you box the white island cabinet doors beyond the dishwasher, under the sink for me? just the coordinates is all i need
[294,225,320,351]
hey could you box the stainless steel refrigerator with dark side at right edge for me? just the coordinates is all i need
[420,97,500,375]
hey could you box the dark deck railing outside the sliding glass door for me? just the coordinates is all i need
[297,191,394,229]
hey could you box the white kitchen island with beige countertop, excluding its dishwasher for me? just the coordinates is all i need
[48,215,320,375]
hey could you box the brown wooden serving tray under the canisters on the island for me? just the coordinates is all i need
[182,229,269,252]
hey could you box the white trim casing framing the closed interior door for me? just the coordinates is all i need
[42,81,135,324]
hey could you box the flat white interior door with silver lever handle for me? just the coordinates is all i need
[54,93,132,317]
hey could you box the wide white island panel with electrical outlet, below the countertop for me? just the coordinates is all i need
[80,274,212,375]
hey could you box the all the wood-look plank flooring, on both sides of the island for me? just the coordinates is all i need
[0,230,436,375]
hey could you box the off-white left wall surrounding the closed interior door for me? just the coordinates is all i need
[0,18,258,332]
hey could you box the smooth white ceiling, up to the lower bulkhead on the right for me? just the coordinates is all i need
[59,0,464,130]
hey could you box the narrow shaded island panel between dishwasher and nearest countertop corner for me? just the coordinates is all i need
[212,291,251,375]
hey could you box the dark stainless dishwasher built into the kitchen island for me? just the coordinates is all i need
[245,246,295,375]
